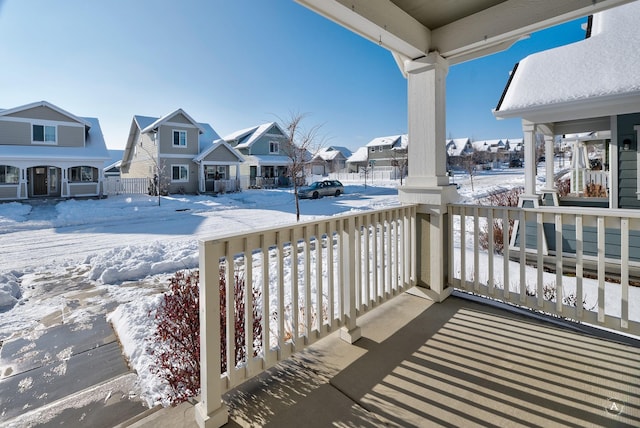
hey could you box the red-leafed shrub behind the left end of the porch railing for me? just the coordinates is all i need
[152,267,262,405]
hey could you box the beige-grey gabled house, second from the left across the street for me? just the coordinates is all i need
[120,109,243,194]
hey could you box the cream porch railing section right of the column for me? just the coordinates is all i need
[448,205,640,335]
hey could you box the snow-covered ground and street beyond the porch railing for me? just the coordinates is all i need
[7,164,632,406]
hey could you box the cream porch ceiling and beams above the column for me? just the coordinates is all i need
[296,0,632,67]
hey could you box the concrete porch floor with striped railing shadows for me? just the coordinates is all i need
[128,291,640,427]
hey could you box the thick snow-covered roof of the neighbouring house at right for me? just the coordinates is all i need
[494,1,640,123]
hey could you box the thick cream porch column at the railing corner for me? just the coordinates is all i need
[398,52,458,301]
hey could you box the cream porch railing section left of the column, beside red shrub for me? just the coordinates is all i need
[197,206,416,425]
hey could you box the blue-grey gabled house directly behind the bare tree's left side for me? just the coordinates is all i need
[224,122,292,187]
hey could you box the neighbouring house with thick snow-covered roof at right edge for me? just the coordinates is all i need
[494,2,640,260]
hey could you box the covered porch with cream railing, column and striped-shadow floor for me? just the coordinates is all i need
[195,0,640,427]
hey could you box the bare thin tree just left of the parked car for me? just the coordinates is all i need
[281,113,323,221]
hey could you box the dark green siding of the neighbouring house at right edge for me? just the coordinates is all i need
[617,113,640,208]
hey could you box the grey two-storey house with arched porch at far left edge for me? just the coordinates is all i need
[0,101,109,200]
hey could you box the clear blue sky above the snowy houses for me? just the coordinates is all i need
[0,0,586,150]
